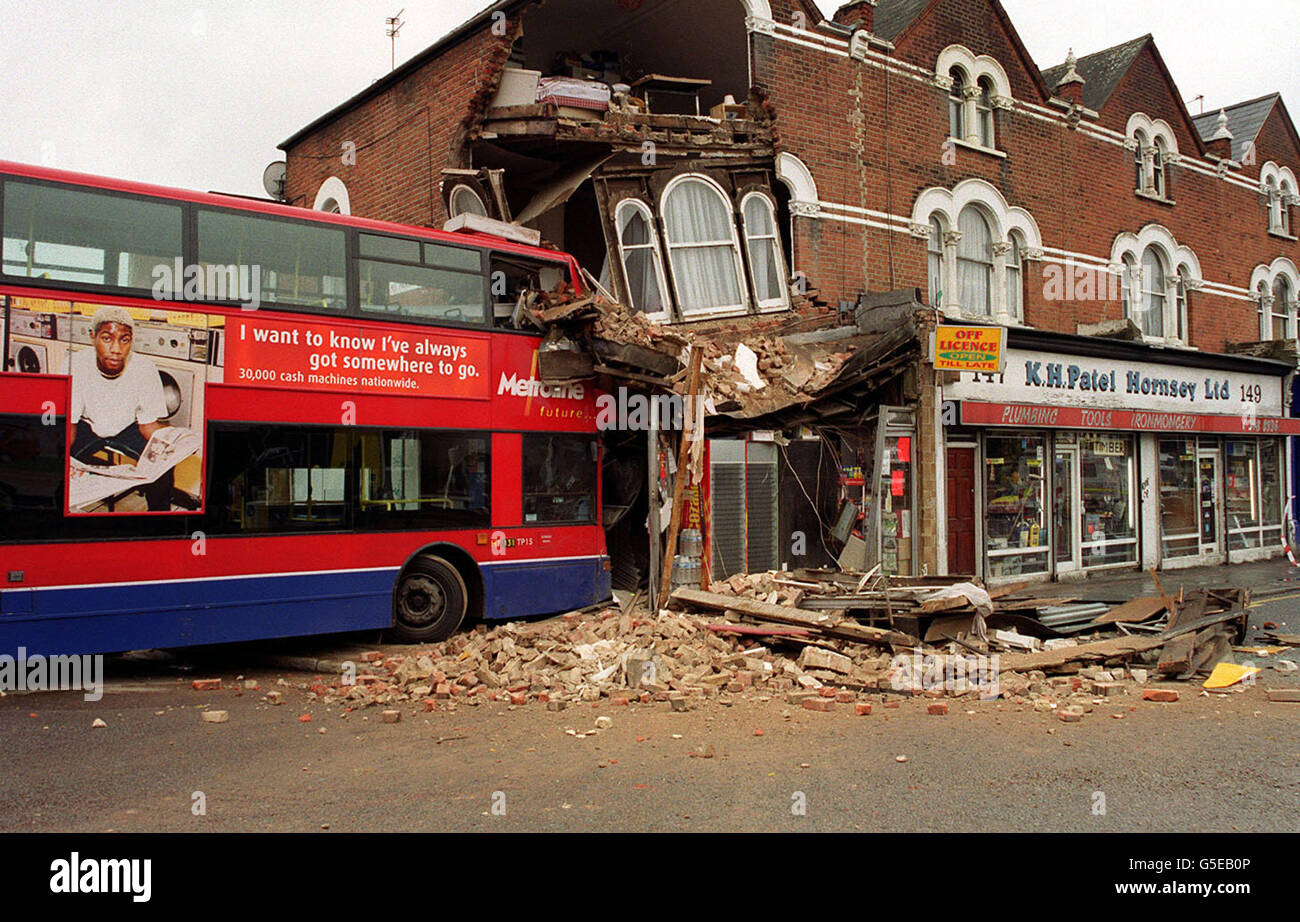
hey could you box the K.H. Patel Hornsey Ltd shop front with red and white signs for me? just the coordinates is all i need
[940,330,1300,581]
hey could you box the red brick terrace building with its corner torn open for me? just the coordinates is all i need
[282,0,1300,590]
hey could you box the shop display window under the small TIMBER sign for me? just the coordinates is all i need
[1079,433,1138,567]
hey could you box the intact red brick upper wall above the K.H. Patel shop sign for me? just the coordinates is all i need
[754,0,1300,350]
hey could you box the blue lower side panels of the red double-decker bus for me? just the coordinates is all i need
[0,558,610,655]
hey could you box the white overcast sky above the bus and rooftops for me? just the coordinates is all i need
[0,0,1300,195]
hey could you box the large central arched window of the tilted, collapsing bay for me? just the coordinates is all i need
[663,176,745,316]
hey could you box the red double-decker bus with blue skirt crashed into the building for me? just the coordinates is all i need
[0,163,610,654]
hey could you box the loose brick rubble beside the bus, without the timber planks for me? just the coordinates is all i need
[301,609,891,710]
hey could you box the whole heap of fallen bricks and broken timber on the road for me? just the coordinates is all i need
[301,571,1290,722]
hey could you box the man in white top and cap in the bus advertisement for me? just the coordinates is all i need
[69,307,174,512]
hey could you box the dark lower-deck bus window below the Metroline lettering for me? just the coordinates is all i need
[523,434,597,525]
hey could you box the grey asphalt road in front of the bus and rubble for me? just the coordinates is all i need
[0,632,1300,834]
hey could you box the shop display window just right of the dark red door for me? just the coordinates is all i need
[984,436,1050,579]
